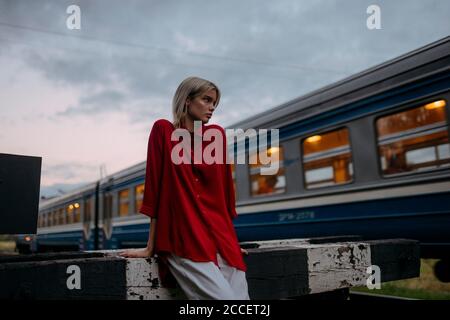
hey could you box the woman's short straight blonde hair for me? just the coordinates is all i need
[172,77,220,128]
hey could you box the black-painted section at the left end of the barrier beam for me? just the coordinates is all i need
[0,257,126,299]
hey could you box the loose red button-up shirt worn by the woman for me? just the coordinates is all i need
[139,119,247,271]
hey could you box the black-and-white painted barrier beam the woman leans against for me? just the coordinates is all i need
[0,237,420,300]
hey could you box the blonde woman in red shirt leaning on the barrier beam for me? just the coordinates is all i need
[121,77,249,300]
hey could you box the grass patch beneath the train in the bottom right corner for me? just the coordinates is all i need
[351,259,450,300]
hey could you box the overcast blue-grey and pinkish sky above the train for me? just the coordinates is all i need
[0,0,450,194]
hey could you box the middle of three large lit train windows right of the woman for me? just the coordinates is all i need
[302,128,353,189]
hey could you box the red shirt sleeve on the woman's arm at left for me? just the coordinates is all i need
[139,122,164,218]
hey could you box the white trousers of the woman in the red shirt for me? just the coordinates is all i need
[167,254,250,300]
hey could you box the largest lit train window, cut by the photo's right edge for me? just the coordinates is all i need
[376,100,450,175]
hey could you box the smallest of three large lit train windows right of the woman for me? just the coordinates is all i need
[249,147,286,196]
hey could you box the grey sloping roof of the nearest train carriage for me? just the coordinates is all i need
[227,36,450,130]
